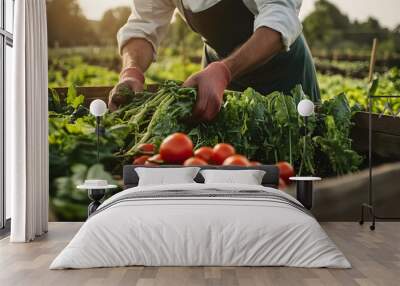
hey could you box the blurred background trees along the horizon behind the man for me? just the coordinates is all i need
[46,0,400,53]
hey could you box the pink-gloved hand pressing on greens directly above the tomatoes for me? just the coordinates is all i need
[183,62,231,121]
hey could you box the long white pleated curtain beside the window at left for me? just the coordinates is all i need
[6,0,49,242]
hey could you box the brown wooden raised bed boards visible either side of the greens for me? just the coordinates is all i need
[50,84,400,164]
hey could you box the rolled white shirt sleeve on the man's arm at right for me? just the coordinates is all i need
[254,0,303,50]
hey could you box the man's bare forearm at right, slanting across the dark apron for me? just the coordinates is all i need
[223,27,283,79]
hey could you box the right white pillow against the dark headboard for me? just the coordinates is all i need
[200,170,265,185]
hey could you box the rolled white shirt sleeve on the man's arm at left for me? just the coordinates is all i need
[117,0,176,59]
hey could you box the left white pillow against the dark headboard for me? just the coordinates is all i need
[135,167,200,186]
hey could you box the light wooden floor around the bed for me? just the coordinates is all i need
[0,222,400,286]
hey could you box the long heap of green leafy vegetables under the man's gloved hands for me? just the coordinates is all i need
[105,81,361,176]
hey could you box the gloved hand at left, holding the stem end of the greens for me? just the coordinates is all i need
[108,67,145,111]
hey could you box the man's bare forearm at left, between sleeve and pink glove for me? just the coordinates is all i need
[122,38,153,72]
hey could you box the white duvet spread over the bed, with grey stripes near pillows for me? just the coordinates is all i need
[50,184,351,269]
